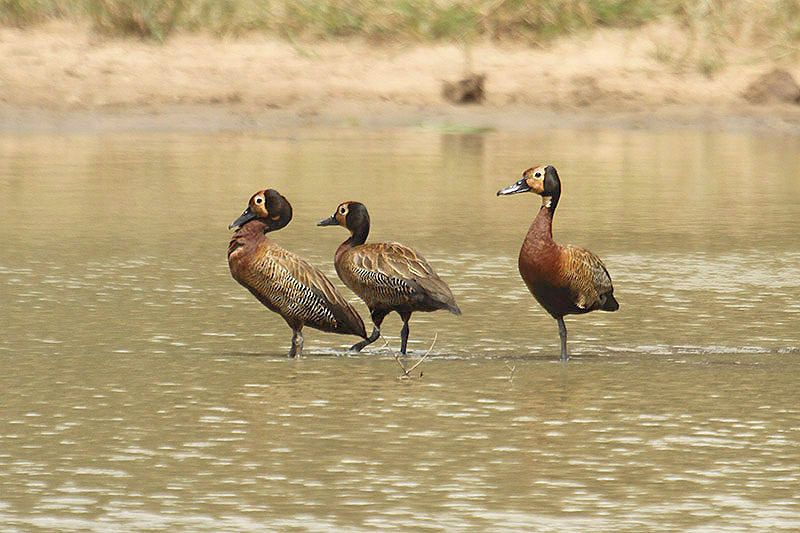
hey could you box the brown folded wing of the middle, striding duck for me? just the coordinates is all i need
[343,243,461,314]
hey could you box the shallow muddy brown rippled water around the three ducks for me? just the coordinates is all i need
[0,124,800,532]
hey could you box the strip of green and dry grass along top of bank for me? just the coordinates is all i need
[0,0,800,57]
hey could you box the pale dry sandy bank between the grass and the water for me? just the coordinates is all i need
[0,22,800,135]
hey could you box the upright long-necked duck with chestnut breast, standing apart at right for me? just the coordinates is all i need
[497,165,619,361]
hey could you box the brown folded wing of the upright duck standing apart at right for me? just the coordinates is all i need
[561,246,614,310]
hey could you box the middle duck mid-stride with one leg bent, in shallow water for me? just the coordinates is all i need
[317,202,461,354]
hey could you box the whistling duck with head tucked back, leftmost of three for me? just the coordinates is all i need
[228,189,367,357]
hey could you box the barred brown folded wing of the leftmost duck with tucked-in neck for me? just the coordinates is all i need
[245,244,366,337]
